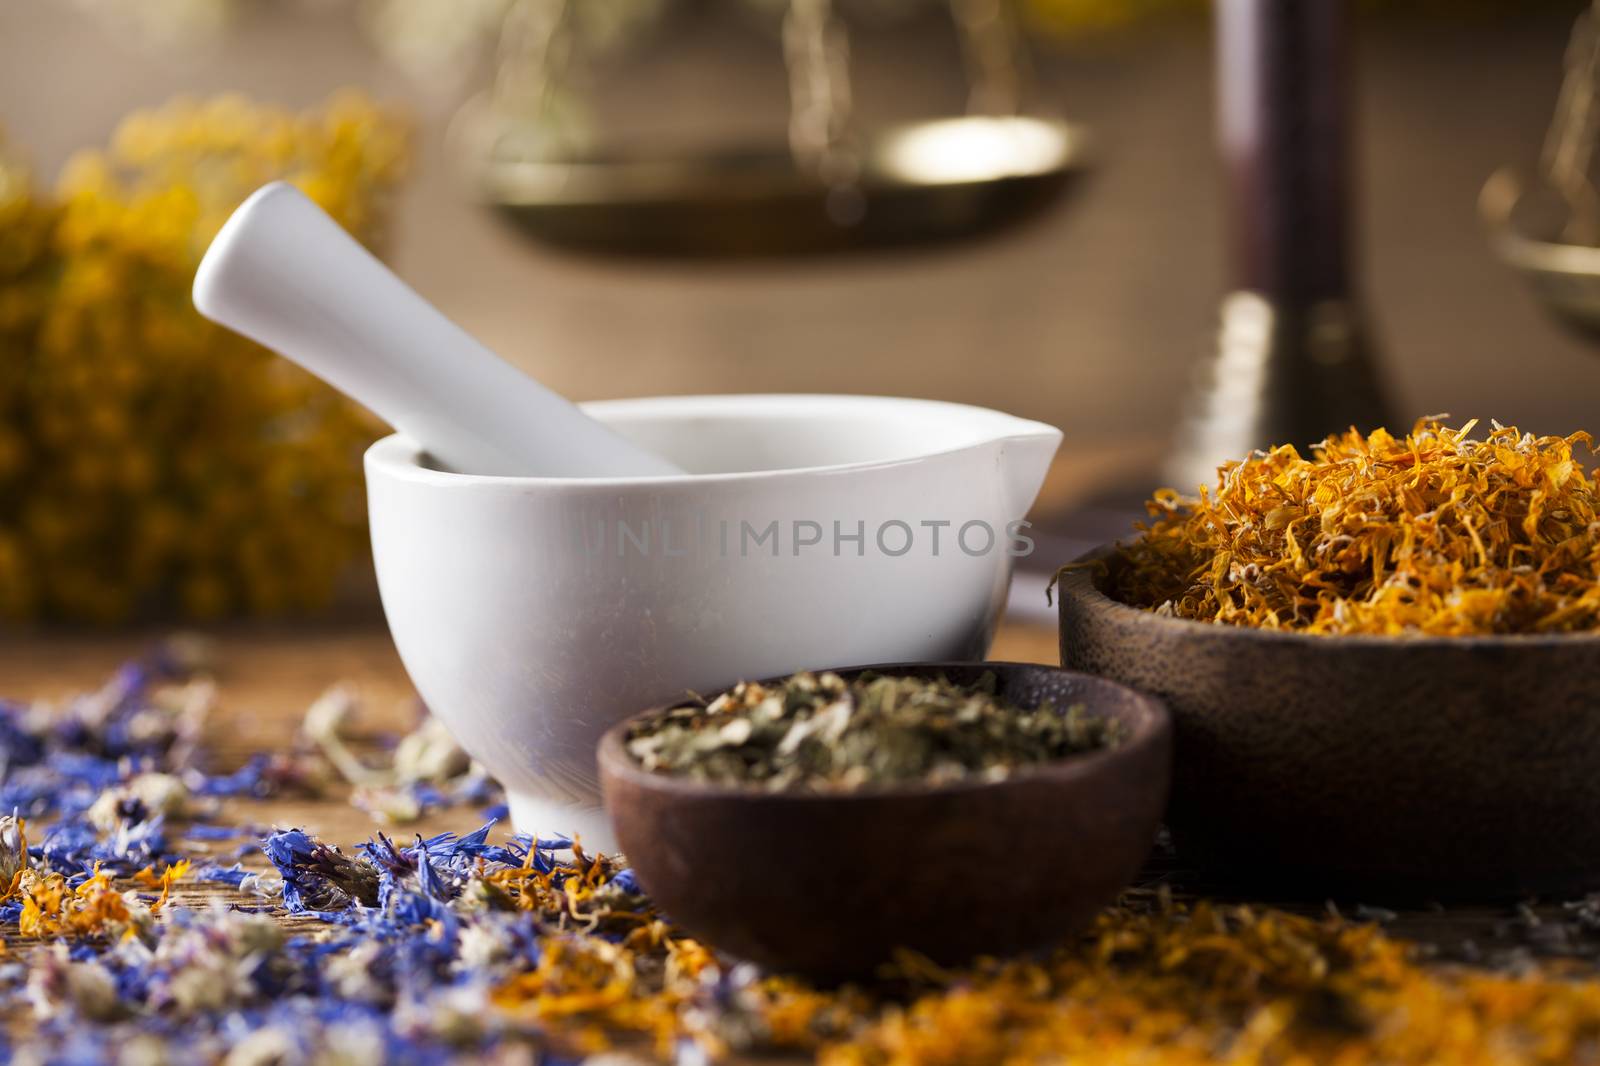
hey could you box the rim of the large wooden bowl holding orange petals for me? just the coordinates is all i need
[1056,541,1600,651]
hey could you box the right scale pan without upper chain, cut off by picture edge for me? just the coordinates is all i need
[1478,170,1600,341]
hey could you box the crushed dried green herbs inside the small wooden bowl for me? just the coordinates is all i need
[627,674,1117,792]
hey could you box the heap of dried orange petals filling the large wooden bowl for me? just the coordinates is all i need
[1109,418,1600,635]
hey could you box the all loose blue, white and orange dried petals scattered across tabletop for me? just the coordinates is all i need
[15,650,1600,1066]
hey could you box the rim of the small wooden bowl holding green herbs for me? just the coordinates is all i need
[597,659,1173,805]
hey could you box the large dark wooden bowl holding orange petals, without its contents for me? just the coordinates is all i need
[1059,549,1600,901]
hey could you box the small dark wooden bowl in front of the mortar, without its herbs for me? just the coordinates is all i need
[600,663,1171,981]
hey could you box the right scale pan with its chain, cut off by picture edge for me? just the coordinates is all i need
[1478,0,1600,339]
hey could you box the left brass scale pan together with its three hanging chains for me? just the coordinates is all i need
[475,0,1083,256]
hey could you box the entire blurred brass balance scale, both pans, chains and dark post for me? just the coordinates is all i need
[477,0,1574,496]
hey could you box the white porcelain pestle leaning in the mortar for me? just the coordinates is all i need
[194,181,683,477]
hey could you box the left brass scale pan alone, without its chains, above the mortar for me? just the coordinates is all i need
[482,115,1083,256]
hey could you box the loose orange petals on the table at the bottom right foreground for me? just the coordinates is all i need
[818,900,1600,1066]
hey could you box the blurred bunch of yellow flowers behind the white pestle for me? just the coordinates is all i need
[0,93,408,621]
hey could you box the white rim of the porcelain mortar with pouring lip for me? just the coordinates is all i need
[363,392,1062,491]
